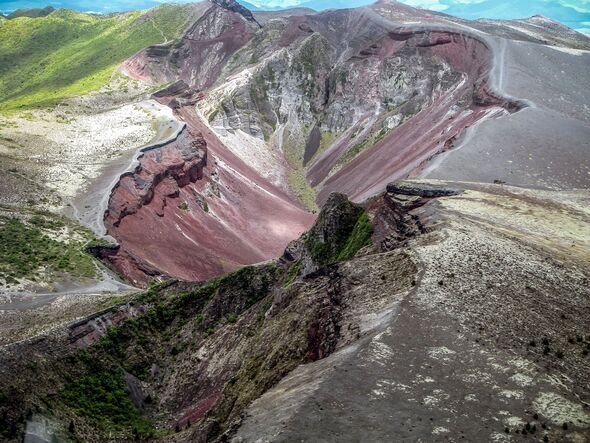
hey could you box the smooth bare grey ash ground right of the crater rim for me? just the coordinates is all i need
[423,40,590,189]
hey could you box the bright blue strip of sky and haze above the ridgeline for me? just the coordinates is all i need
[0,0,590,35]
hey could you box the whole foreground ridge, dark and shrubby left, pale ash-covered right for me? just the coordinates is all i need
[0,182,590,442]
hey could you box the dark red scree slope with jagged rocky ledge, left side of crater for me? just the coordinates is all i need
[102,109,313,286]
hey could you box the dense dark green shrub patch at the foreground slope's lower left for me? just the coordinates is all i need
[60,369,155,438]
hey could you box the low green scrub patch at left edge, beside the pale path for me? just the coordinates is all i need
[0,216,96,283]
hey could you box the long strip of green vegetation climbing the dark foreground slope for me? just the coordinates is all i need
[48,264,283,441]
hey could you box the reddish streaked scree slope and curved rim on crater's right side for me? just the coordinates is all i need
[308,29,525,204]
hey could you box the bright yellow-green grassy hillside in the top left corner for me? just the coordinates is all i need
[0,5,191,113]
